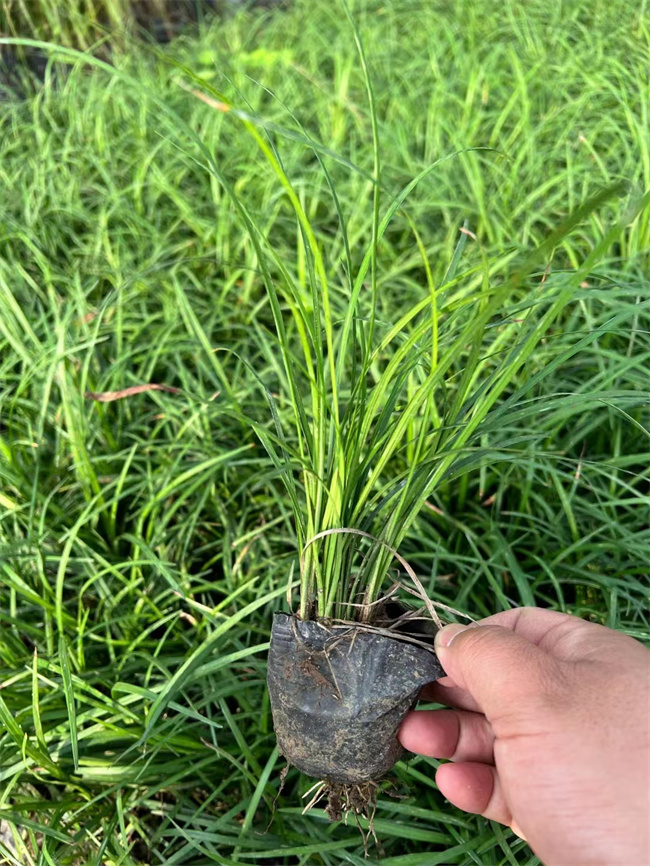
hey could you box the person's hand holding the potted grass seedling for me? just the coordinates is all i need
[399,608,650,866]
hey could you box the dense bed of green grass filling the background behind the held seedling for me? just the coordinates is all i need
[0,0,650,866]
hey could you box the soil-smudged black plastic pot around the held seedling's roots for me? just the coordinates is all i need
[268,613,444,784]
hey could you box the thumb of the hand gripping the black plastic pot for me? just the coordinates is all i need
[436,623,564,721]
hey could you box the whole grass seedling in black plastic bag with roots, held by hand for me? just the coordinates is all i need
[181,8,629,832]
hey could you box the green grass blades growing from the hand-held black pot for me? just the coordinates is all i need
[185,18,647,619]
